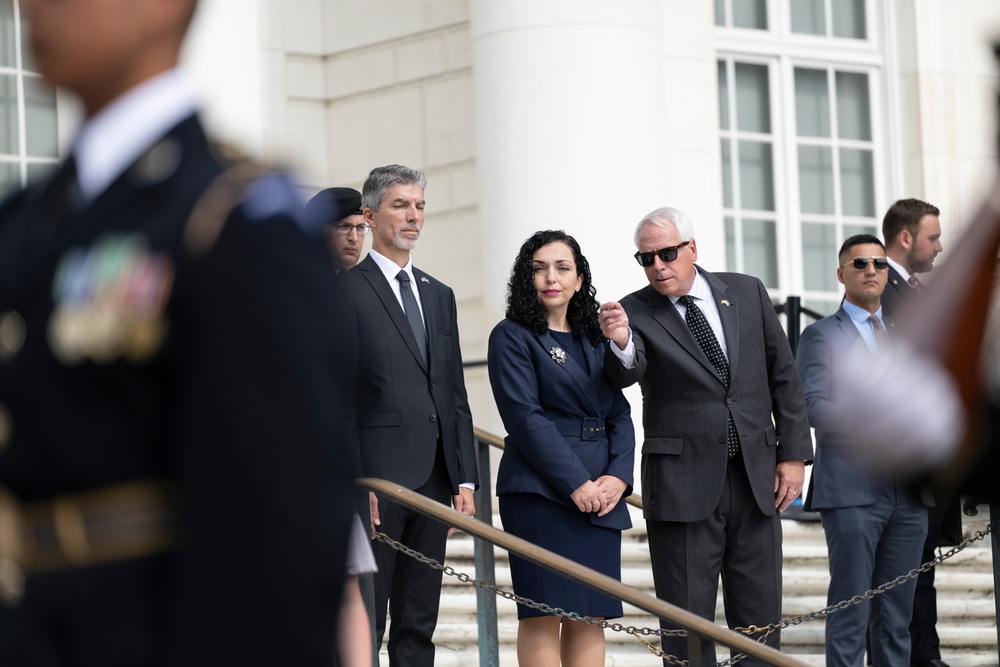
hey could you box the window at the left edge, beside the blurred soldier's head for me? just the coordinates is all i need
[0,0,58,197]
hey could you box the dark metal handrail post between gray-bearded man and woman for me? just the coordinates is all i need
[473,438,500,667]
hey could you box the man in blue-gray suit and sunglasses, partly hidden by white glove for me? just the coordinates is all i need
[798,234,932,667]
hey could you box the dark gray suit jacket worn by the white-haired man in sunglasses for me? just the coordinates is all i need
[605,267,812,521]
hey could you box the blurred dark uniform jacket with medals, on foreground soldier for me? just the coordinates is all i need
[0,116,353,665]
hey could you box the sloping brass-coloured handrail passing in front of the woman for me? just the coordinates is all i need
[357,477,807,667]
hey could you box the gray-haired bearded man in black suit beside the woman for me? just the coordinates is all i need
[340,165,479,667]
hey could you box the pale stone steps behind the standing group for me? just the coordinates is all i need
[381,508,998,667]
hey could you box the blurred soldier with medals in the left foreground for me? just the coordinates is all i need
[0,0,354,667]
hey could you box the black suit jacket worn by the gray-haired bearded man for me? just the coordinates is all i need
[338,256,479,494]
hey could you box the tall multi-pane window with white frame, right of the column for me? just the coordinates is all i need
[715,0,886,313]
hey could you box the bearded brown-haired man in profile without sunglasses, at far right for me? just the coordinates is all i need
[882,199,962,667]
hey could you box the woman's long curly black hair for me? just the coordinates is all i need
[507,230,604,345]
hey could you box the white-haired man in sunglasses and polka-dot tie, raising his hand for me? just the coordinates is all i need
[600,208,812,665]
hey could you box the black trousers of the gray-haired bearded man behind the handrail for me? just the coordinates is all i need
[373,444,452,667]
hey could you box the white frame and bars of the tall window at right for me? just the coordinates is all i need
[715,0,900,316]
